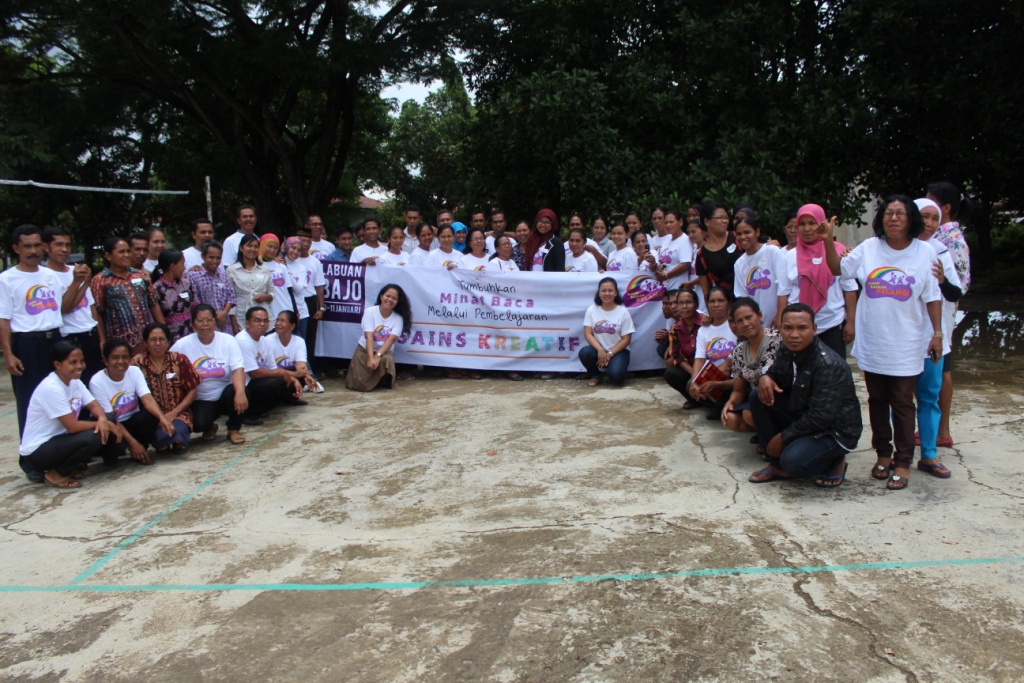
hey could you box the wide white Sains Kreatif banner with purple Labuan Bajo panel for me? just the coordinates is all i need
[316,262,666,372]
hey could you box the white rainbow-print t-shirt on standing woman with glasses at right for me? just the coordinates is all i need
[840,238,941,377]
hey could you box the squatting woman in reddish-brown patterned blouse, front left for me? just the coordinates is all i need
[131,321,200,453]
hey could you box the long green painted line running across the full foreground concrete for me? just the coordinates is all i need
[0,557,1011,593]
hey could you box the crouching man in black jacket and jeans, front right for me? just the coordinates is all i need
[749,303,863,488]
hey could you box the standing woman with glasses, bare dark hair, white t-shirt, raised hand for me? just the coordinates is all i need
[818,195,943,490]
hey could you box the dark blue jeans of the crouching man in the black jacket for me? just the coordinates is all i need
[750,391,847,477]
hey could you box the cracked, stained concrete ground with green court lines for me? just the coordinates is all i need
[0,366,1024,683]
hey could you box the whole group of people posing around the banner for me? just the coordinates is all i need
[0,183,970,489]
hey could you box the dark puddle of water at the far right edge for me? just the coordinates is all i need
[953,295,1024,389]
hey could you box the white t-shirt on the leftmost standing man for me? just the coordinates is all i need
[0,267,63,332]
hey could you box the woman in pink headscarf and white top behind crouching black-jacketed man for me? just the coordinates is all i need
[774,204,857,358]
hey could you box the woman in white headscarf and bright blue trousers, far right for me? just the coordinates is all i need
[914,194,964,479]
